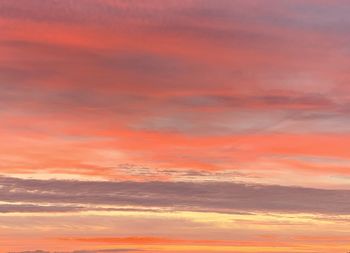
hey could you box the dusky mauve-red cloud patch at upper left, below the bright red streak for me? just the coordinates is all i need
[0,40,191,89]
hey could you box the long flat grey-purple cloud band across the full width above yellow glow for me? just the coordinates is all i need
[0,177,350,214]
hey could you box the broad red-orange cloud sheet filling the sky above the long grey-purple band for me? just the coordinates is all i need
[0,0,349,187]
